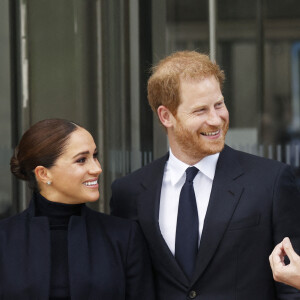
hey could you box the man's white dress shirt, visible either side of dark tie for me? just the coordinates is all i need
[159,149,220,255]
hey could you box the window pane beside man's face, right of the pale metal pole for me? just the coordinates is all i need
[217,0,261,150]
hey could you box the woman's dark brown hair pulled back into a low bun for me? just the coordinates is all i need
[10,119,80,190]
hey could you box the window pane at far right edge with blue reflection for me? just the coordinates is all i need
[262,0,300,181]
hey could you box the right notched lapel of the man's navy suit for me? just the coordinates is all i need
[192,146,243,284]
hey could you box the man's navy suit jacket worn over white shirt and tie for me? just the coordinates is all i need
[111,146,300,300]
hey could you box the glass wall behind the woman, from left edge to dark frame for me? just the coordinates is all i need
[0,0,103,217]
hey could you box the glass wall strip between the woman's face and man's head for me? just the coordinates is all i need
[102,0,154,211]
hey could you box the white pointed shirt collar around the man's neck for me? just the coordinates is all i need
[167,149,220,185]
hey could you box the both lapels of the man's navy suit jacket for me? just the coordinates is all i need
[137,146,243,287]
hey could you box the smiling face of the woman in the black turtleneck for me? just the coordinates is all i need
[41,127,102,204]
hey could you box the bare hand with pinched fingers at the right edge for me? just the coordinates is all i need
[269,238,300,289]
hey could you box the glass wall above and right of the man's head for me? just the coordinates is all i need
[166,0,300,183]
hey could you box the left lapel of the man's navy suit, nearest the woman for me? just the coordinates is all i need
[137,155,189,286]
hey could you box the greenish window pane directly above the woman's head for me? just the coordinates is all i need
[26,0,98,134]
